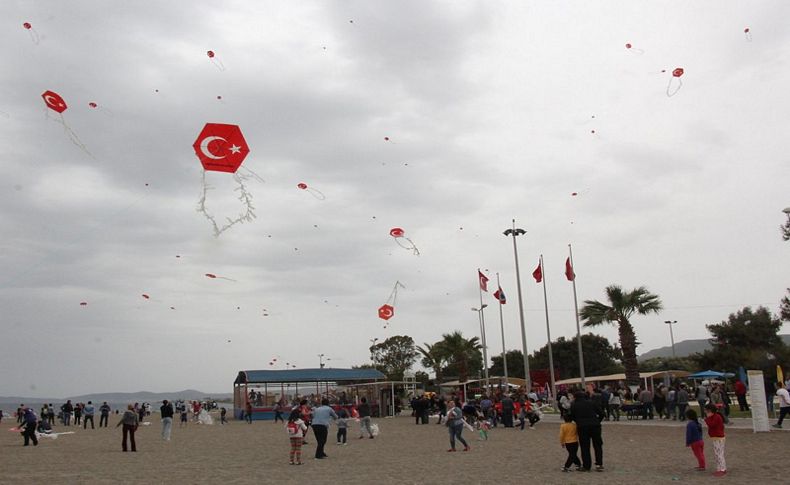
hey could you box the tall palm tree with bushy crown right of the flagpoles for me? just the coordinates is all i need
[579,285,663,385]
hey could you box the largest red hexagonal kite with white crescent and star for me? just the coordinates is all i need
[192,123,250,173]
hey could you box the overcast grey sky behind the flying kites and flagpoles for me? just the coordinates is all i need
[0,0,790,396]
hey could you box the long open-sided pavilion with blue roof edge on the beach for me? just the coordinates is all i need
[233,368,386,420]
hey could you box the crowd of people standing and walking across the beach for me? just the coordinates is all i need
[7,381,790,476]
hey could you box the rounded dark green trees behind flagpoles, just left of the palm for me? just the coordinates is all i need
[529,334,623,379]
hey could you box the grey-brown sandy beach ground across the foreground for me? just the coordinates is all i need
[0,416,790,484]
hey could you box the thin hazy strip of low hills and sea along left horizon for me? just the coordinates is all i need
[0,389,233,411]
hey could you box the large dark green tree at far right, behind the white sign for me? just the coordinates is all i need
[691,307,790,375]
